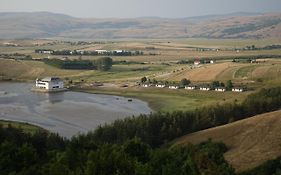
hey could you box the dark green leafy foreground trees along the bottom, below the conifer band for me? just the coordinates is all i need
[0,127,234,175]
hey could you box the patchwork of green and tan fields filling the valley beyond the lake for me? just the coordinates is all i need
[0,39,281,111]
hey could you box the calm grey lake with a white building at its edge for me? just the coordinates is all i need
[0,82,152,138]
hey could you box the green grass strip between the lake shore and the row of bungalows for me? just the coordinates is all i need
[77,87,248,112]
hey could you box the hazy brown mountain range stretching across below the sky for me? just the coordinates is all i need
[0,12,281,39]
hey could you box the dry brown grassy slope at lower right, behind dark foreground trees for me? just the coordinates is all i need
[175,110,281,171]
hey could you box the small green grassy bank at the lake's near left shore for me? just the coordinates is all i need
[0,120,44,134]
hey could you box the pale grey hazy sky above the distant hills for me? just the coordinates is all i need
[0,0,281,18]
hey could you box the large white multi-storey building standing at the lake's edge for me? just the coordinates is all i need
[35,77,64,90]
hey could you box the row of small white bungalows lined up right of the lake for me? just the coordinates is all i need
[142,84,245,92]
